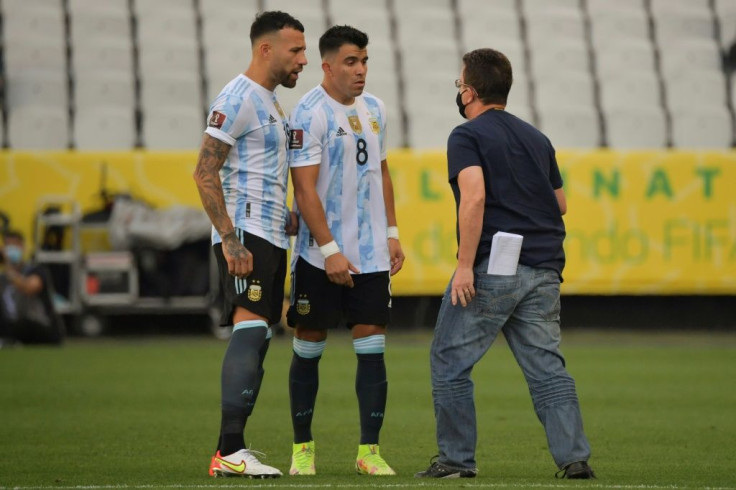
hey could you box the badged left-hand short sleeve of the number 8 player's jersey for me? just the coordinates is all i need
[289,106,326,167]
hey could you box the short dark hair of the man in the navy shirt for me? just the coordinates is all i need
[463,48,514,105]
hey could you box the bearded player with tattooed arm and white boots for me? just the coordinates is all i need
[194,11,307,478]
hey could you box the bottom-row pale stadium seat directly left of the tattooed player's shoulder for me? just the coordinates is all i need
[143,105,205,150]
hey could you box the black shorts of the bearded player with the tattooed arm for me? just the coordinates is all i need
[213,228,286,326]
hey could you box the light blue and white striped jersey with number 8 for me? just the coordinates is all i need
[289,86,391,273]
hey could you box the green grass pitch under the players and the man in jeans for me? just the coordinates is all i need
[0,330,736,489]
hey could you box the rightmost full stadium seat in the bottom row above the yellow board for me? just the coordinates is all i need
[672,106,733,148]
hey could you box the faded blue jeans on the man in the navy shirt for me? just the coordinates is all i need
[430,260,590,468]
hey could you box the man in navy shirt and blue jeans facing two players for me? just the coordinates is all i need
[416,49,594,479]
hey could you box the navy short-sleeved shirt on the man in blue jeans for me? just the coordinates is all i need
[447,110,565,278]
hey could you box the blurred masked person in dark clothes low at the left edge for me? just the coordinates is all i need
[0,230,64,344]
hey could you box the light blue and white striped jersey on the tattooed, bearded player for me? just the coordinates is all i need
[205,74,289,249]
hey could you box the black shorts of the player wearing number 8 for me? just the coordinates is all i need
[286,257,391,330]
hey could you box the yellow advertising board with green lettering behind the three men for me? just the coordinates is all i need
[0,151,736,295]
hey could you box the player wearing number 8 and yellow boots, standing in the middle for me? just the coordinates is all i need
[287,26,404,475]
